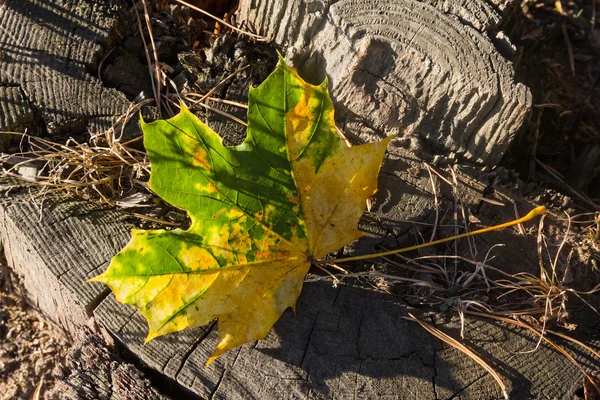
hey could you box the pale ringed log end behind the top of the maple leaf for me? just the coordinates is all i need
[237,0,531,164]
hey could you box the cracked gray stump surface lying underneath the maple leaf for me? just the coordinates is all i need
[0,156,600,399]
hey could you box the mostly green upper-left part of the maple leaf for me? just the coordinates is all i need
[142,97,306,244]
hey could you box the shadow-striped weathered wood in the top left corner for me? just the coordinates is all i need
[0,0,129,132]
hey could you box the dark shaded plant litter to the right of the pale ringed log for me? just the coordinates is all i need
[504,0,600,206]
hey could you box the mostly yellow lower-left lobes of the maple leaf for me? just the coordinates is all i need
[90,230,310,361]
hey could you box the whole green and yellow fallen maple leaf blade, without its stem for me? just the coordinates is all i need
[86,59,389,363]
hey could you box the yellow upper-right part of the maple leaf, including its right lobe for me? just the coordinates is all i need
[286,68,392,259]
